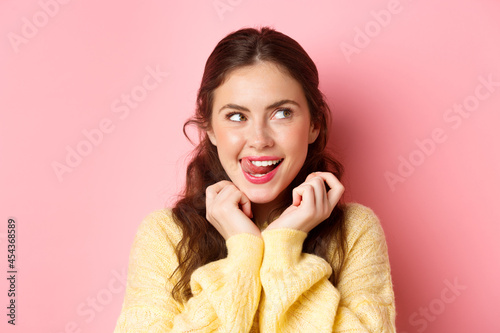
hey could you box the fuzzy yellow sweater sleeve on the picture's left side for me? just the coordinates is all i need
[114,210,263,333]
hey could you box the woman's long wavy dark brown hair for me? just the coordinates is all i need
[172,27,346,301]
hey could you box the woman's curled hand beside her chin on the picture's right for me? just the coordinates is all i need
[266,172,344,233]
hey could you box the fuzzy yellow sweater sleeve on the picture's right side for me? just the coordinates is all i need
[259,204,395,333]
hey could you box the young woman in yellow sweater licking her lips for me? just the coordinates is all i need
[115,28,395,333]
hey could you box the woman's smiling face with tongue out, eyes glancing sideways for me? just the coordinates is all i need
[208,62,319,204]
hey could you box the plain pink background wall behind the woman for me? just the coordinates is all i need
[0,0,500,333]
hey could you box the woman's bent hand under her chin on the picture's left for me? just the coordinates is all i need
[206,180,260,240]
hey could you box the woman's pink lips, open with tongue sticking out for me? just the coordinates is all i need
[240,156,282,184]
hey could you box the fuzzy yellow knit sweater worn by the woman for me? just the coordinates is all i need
[115,203,396,333]
